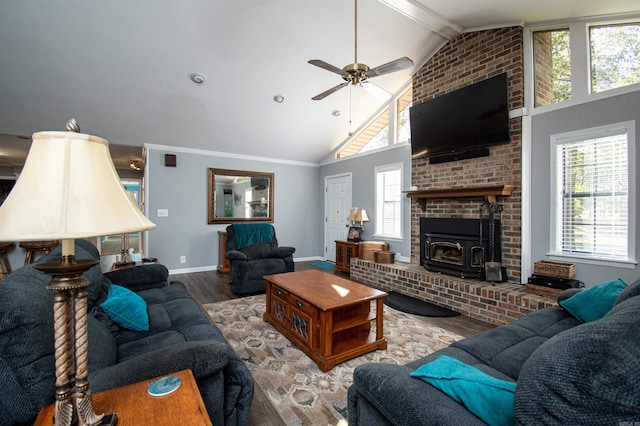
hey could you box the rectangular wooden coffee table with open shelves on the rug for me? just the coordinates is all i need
[263,270,387,371]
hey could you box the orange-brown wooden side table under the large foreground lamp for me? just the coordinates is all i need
[35,370,212,426]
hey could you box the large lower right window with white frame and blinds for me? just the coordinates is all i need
[551,122,635,261]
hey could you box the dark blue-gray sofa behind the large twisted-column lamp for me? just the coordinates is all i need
[0,240,253,425]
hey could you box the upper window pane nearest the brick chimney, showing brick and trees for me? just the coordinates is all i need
[533,29,571,106]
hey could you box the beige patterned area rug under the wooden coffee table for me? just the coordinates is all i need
[204,295,462,426]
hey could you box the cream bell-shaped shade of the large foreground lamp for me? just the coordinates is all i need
[0,132,156,241]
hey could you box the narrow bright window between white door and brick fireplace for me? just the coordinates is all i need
[375,163,402,238]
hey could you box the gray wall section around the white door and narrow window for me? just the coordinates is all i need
[319,145,411,261]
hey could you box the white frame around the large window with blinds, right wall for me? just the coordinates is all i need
[547,121,637,268]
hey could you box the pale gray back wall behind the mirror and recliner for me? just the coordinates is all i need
[146,146,323,272]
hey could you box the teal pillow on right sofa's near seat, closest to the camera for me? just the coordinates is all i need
[409,355,516,426]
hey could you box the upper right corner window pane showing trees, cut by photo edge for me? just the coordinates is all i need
[589,23,640,93]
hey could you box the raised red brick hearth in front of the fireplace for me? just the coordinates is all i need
[351,258,556,325]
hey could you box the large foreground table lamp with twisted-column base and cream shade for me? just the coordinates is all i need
[0,119,155,426]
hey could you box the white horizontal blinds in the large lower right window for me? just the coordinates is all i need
[556,133,629,259]
